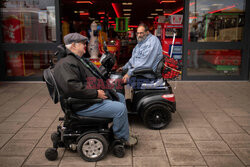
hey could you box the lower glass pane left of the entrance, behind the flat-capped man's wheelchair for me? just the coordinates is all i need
[5,51,54,77]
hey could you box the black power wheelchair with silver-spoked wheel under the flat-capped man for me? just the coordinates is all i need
[43,67,125,162]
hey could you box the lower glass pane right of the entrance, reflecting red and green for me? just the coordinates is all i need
[188,49,241,76]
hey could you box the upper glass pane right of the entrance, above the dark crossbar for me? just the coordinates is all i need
[189,0,245,42]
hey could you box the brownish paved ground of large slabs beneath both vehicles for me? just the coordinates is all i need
[0,81,250,167]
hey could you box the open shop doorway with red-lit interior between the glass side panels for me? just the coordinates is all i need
[60,0,184,75]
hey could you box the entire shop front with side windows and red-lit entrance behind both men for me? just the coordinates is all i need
[0,0,250,81]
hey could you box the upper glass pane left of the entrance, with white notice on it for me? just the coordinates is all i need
[1,0,56,43]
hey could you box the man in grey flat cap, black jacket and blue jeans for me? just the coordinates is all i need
[54,33,137,146]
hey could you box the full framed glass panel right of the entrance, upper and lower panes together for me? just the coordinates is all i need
[183,0,250,80]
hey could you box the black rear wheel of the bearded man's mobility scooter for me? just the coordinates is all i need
[142,104,172,129]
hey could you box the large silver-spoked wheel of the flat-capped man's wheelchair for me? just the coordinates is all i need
[77,133,108,162]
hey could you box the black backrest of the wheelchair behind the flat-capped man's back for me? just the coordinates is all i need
[43,68,60,104]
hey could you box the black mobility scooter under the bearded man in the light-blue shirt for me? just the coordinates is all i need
[100,43,176,129]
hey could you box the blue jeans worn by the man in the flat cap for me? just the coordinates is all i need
[76,93,129,141]
